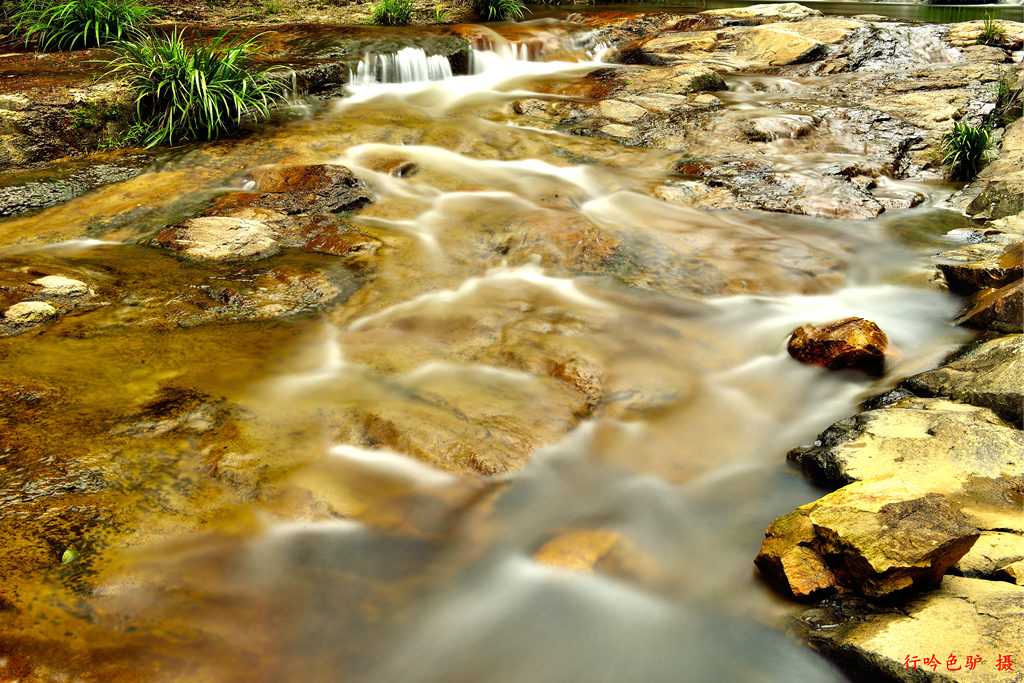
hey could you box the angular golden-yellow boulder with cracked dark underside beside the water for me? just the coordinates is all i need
[755,476,979,598]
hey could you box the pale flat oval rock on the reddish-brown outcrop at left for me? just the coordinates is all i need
[155,216,278,261]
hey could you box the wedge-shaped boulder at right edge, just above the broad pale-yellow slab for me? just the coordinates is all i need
[900,334,1024,428]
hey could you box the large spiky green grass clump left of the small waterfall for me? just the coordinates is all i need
[108,31,287,147]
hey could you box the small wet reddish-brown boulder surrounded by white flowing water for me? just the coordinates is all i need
[786,317,889,375]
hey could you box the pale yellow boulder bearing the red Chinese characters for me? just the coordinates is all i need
[798,577,1024,683]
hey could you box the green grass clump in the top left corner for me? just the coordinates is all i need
[12,0,157,50]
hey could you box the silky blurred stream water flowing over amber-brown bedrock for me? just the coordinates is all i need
[0,13,983,683]
